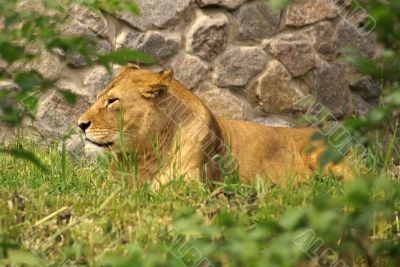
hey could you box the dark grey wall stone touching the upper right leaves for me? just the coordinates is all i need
[336,20,376,57]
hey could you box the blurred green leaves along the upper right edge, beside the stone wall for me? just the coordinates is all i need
[343,0,400,155]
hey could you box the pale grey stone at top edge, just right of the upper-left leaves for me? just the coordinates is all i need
[118,0,191,31]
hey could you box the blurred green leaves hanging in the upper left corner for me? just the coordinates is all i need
[0,0,155,170]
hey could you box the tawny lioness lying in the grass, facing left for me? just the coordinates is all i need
[78,65,350,184]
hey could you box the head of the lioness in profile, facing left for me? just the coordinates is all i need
[78,65,173,151]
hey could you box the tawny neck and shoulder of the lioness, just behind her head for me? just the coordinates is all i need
[118,83,219,185]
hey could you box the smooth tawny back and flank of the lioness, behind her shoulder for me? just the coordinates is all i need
[218,118,315,183]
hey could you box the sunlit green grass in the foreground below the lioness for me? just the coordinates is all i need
[0,140,400,266]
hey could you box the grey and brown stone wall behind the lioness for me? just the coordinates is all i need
[10,0,380,154]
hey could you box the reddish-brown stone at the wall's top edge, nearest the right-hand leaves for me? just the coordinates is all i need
[284,0,338,27]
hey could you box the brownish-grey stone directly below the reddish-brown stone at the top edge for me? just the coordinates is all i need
[270,35,315,77]
